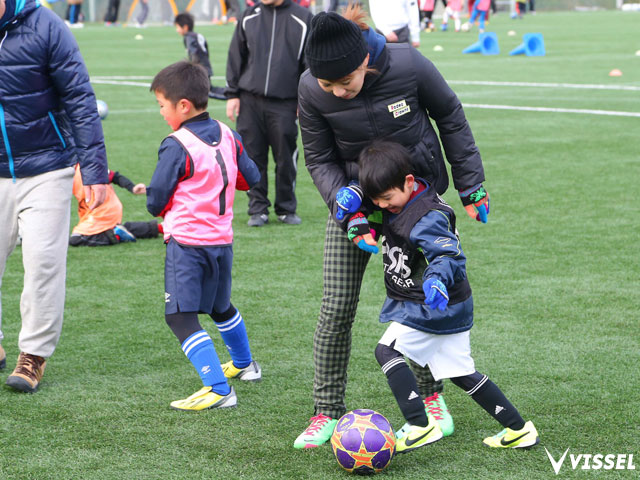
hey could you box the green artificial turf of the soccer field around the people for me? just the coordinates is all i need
[0,12,640,480]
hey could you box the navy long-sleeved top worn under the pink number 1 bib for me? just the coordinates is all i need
[147,112,260,217]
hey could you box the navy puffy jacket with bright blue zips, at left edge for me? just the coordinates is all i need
[0,0,109,185]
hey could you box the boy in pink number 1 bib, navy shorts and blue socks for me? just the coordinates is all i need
[147,61,262,411]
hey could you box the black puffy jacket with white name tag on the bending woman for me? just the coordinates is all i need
[298,40,484,223]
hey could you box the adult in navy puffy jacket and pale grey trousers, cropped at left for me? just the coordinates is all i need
[0,0,109,393]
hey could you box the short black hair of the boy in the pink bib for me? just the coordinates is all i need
[149,60,211,110]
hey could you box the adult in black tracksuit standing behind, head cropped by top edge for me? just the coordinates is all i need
[225,0,312,227]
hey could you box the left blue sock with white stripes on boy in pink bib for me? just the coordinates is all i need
[182,330,231,395]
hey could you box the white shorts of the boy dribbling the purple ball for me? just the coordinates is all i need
[378,322,476,380]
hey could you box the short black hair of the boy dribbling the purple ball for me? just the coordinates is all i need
[358,140,413,199]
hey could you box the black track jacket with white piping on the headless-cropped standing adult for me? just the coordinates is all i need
[225,0,313,99]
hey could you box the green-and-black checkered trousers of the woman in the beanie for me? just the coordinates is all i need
[313,217,442,418]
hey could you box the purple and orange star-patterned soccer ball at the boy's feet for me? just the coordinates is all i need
[331,410,396,474]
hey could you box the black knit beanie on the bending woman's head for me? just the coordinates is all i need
[304,12,368,80]
